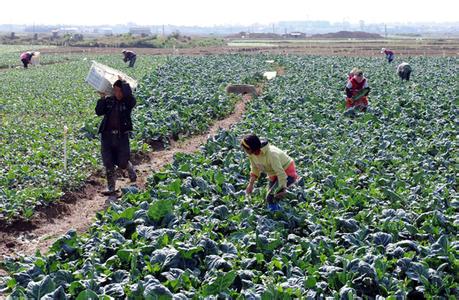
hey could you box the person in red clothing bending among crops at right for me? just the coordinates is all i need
[345,69,370,111]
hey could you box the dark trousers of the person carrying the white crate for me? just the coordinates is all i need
[101,132,131,170]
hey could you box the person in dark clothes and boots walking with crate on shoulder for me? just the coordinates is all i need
[96,77,137,195]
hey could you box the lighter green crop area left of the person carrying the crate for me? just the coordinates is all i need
[0,56,157,221]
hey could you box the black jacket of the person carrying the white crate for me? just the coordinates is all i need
[96,81,136,133]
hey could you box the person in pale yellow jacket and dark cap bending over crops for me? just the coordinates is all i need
[241,134,298,211]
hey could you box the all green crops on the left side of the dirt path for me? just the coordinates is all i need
[0,51,261,221]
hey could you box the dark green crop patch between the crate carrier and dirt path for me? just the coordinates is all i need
[135,55,268,144]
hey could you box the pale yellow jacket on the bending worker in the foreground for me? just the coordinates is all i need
[249,144,293,187]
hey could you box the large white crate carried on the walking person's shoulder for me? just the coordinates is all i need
[85,61,137,95]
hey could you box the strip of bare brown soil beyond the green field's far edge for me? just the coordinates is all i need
[35,39,459,58]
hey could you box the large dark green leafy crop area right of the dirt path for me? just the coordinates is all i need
[4,56,459,299]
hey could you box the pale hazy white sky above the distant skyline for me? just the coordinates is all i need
[0,0,459,25]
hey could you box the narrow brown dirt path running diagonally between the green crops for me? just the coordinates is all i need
[0,96,250,262]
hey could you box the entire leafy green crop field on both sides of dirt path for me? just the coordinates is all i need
[0,50,459,299]
